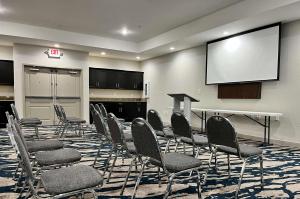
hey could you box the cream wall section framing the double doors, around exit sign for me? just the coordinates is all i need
[13,44,89,118]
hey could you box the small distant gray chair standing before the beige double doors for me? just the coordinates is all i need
[54,104,86,137]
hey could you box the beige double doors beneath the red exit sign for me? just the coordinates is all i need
[24,66,81,124]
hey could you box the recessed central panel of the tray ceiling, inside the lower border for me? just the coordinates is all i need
[0,0,241,42]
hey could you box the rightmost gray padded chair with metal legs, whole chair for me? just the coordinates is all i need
[206,116,263,198]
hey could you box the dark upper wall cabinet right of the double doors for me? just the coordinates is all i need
[89,68,144,90]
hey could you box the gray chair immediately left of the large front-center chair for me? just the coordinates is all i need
[105,113,136,182]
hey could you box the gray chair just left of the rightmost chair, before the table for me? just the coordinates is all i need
[171,112,208,157]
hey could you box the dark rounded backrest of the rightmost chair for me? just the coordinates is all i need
[206,116,239,152]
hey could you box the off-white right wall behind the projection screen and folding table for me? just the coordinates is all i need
[142,21,300,143]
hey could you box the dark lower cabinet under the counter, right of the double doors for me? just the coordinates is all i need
[90,102,147,123]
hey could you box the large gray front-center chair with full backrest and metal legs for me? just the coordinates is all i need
[127,118,201,198]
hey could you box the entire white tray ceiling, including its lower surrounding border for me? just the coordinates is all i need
[0,0,300,61]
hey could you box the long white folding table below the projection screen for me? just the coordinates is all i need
[192,108,282,145]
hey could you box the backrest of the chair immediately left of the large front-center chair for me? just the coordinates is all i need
[107,113,125,146]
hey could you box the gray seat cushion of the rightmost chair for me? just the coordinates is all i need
[217,144,263,157]
